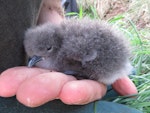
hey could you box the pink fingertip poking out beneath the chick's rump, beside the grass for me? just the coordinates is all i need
[112,77,138,95]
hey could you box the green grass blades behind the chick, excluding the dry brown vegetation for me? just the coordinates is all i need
[66,1,150,113]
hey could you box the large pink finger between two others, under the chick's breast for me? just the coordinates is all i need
[16,72,75,107]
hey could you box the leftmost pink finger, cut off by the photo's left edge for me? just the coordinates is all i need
[0,67,49,97]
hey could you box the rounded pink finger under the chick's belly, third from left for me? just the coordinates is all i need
[59,80,106,105]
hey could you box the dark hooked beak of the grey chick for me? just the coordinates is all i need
[28,55,43,67]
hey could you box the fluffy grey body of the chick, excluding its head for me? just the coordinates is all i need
[58,19,132,84]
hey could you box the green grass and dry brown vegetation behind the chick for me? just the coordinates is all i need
[67,0,150,113]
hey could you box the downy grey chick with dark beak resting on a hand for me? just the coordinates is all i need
[24,19,132,84]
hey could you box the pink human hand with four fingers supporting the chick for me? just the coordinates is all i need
[0,67,137,107]
